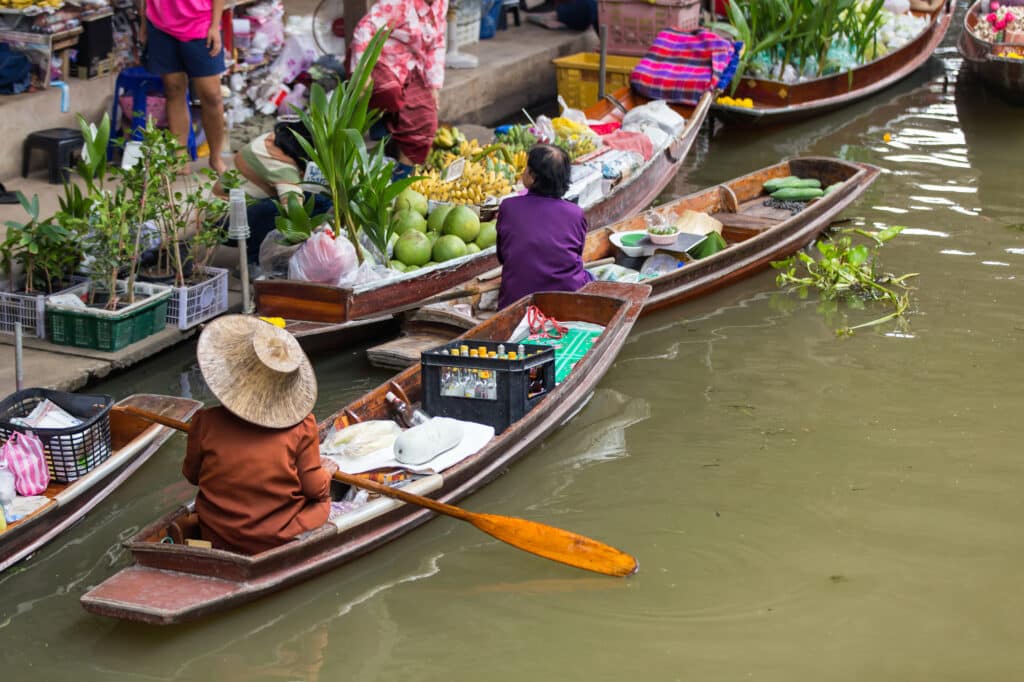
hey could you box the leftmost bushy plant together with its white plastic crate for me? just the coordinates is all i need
[0,191,88,338]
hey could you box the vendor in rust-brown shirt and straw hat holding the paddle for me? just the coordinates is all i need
[182,315,337,554]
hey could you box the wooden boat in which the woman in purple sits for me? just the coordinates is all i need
[367,157,880,369]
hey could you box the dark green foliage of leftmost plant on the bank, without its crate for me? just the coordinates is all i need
[0,191,82,294]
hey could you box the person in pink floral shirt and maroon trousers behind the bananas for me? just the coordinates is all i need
[351,0,447,175]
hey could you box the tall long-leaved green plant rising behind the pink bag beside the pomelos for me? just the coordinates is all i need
[294,30,389,264]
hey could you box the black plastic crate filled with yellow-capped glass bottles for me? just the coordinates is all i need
[421,341,555,433]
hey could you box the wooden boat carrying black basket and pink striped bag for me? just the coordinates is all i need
[0,395,202,570]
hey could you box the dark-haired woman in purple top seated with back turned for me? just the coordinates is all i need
[498,144,593,308]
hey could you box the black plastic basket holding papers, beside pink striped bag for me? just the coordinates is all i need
[0,388,114,483]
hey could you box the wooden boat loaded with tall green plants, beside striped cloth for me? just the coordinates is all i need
[713,0,955,126]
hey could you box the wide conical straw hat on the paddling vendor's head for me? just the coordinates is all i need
[196,315,316,429]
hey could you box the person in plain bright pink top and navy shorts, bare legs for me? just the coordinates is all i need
[139,0,227,174]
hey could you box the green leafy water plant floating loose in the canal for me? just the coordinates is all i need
[772,225,918,335]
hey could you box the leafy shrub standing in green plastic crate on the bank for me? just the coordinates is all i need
[46,115,171,351]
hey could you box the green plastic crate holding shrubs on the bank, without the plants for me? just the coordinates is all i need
[46,280,172,351]
